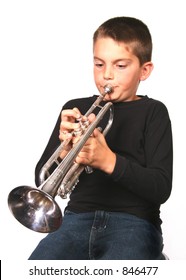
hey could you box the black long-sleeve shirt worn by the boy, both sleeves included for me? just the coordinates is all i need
[35,96,173,229]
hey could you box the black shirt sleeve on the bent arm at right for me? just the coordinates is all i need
[110,103,173,204]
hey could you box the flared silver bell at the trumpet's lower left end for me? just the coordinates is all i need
[8,186,62,233]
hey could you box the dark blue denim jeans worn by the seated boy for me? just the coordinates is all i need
[29,211,164,260]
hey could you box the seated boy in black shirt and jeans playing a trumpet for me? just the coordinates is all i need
[29,17,172,260]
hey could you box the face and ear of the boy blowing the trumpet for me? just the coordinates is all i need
[93,37,153,102]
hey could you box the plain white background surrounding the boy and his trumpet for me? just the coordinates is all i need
[0,0,186,270]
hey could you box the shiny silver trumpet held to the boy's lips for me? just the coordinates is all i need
[8,85,113,233]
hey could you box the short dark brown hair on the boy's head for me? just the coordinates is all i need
[93,17,152,65]
